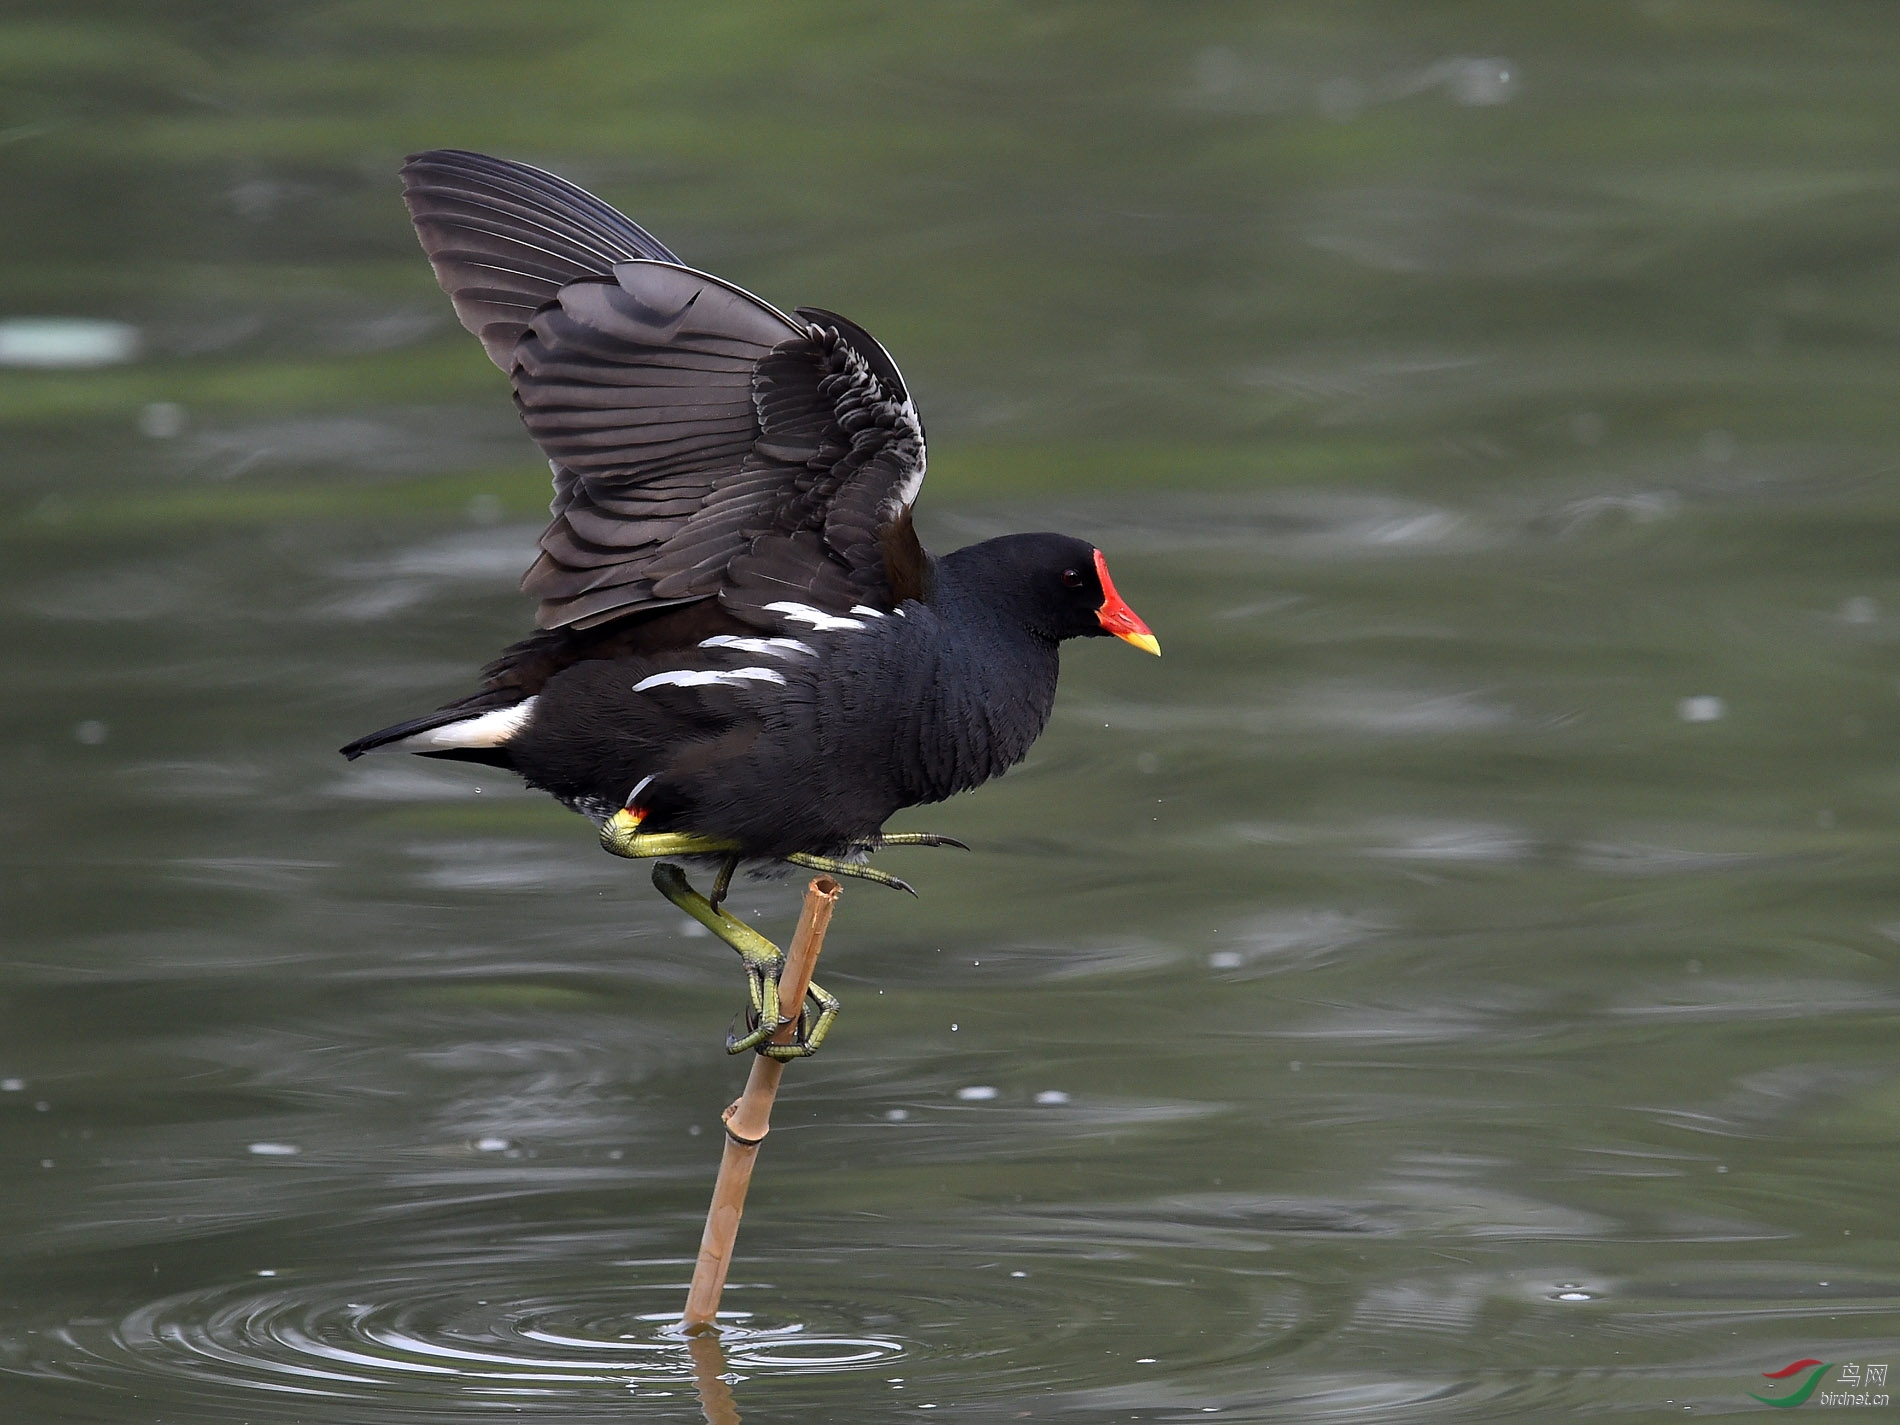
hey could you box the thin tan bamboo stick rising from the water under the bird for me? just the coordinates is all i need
[680,876,840,1332]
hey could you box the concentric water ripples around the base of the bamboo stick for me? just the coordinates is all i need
[26,1260,908,1421]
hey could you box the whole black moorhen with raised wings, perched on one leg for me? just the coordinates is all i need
[342,150,1161,1056]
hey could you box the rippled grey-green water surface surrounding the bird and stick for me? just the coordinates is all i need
[0,0,1900,1425]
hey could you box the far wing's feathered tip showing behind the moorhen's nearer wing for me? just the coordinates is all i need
[403,148,678,371]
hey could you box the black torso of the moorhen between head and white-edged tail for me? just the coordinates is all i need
[509,600,1058,855]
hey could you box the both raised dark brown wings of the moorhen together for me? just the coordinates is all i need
[403,152,927,629]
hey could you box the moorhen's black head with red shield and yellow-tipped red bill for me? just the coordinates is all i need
[944,534,1161,654]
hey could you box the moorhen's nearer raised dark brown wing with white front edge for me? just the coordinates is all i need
[515,262,923,627]
